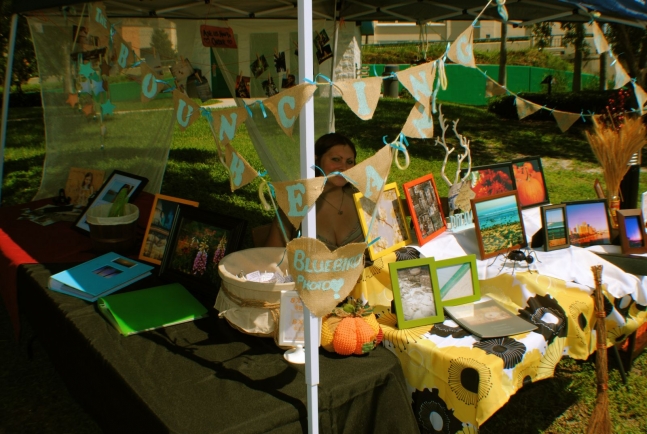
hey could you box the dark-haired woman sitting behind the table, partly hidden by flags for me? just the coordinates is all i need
[265,133,364,251]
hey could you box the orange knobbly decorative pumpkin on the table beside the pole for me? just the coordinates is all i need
[321,298,383,356]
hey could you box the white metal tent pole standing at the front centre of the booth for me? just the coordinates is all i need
[298,0,319,434]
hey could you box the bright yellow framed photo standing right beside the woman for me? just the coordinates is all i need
[353,182,412,261]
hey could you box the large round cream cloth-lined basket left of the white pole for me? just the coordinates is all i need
[215,247,294,341]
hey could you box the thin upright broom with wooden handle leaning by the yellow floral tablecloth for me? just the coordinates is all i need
[586,265,611,434]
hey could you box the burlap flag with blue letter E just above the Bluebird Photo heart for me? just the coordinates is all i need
[272,176,325,228]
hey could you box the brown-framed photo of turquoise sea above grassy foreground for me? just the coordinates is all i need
[471,190,528,259]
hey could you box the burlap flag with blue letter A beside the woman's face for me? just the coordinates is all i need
[344,145,392,202]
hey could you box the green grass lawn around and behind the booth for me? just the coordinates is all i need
[2,99,647,434]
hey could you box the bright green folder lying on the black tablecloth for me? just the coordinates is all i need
[98,283,207,336]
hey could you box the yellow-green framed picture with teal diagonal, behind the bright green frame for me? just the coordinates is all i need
[431,255,481,306]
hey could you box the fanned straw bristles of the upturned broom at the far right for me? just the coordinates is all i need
[586,116,647,198]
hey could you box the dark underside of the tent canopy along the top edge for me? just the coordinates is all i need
[8,0,647,27]
